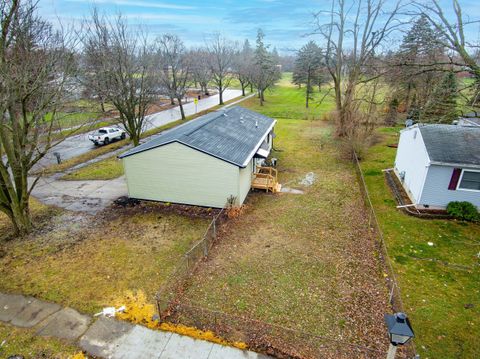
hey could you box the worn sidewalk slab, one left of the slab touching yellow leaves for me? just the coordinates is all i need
[37,308,92,340]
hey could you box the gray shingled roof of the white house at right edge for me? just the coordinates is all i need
[418,125,480,167]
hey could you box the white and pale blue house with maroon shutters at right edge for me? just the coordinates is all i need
[394,125,480,209]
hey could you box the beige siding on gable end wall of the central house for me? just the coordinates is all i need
[123,142,243,208]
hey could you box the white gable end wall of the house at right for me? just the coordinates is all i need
[395,126,430,203]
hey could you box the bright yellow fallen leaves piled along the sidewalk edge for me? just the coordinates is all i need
[113,290,248,350]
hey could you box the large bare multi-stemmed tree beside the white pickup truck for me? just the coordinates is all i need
[83,10,158,146]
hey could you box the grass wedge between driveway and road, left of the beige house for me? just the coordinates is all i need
[61,156,123,181]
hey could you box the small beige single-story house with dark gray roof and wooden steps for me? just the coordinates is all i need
[119,107,276,208]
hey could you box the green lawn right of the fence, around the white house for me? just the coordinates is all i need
[362,128,480,358]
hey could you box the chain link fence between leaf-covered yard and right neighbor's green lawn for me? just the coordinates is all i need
[353,152,416,356]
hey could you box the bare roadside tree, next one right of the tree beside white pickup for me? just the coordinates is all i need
[157,34,190,120]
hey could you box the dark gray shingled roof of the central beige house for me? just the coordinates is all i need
[119,106,275,167]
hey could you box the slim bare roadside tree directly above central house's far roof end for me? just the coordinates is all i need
[207,34,236,105]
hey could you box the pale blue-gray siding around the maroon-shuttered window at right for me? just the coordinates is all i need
[419,165,480,208]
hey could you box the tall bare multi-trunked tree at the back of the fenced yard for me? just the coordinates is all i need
[315,0,401,137]
